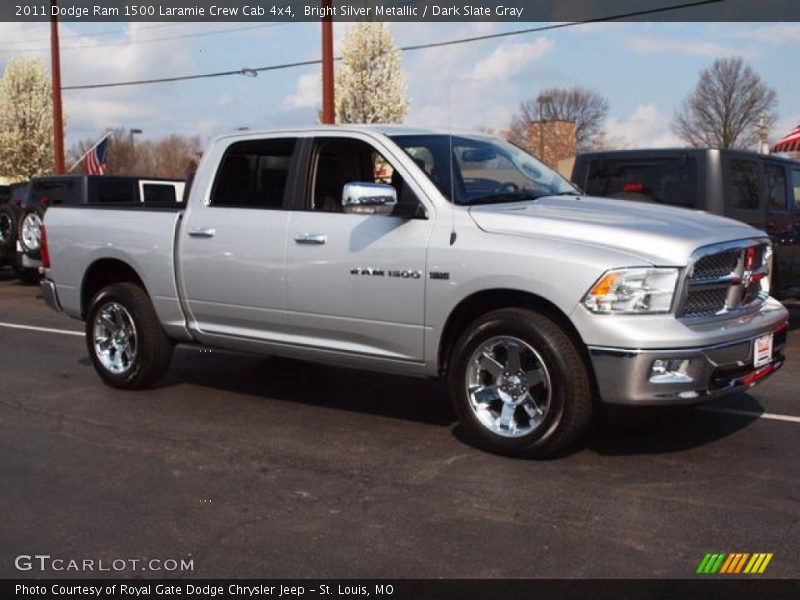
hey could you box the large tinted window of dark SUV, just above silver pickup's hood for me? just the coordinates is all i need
[586,157,697,208]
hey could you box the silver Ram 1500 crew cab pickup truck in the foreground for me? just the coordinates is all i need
[37,127,788,456]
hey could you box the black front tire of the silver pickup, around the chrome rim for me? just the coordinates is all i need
[448,308,593,458]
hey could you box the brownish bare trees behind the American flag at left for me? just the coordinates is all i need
[69,128,203,179]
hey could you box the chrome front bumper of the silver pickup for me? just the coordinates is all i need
[589,322,788,406]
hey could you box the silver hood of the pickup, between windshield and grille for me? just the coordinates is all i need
[470,196,766,266]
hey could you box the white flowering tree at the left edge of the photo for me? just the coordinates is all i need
[0,58,53,180]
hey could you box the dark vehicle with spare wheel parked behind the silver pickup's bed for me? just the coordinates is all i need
[16,175,184,280]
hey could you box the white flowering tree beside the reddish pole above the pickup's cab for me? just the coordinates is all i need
[336,22,408,123]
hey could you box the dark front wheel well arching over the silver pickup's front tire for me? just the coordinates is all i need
[439,289,594,378]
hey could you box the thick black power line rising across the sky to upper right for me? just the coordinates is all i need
[62,0,728,91]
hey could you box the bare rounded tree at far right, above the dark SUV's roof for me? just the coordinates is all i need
[672,58,778,148]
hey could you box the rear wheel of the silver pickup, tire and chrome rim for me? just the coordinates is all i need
[86,283,172,389]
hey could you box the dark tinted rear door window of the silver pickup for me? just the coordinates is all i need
[210,139,296,208]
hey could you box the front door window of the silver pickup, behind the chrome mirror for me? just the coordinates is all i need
[311,138,421,217]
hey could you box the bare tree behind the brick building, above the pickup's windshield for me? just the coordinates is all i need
[508,86,608,150]
